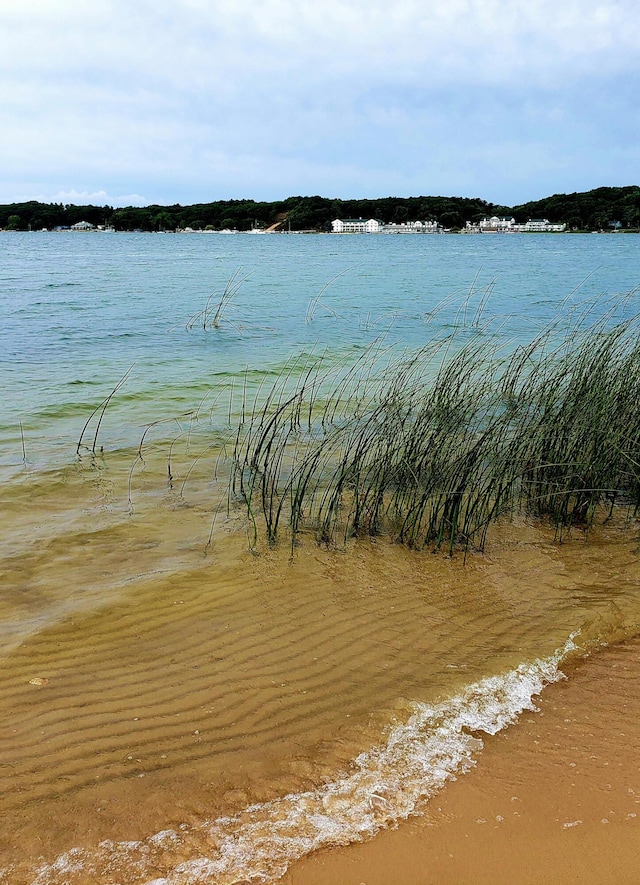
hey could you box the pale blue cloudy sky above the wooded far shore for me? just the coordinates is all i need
[0,0,640,206]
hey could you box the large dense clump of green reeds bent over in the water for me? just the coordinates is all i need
[228,293,640,554]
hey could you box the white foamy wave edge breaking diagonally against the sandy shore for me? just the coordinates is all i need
[21,635,577,885]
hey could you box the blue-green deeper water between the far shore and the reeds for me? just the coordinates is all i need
[0,232,640,467]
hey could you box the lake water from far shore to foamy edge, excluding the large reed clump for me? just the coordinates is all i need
[0,233,640,885]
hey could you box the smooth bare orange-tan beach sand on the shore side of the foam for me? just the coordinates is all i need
[282,639,640,885]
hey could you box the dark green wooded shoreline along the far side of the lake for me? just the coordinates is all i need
[0,185,640,231]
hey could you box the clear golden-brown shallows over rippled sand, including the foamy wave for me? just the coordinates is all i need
[0,456,640,885]
